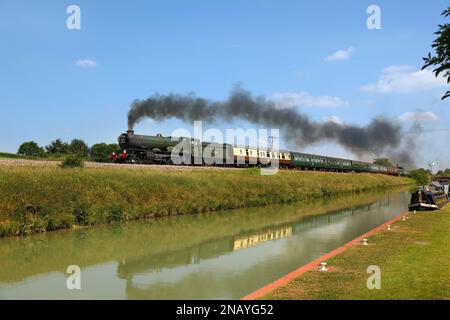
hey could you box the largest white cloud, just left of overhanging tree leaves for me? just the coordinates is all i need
[361,65,447,93]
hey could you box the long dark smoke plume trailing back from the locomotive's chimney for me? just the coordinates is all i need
[128,87,401,160]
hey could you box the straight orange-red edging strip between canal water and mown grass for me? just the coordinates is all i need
[241,211,409,300]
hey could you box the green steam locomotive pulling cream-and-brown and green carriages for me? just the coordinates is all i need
[110,130,404,176]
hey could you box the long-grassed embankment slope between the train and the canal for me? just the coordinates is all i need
[0,167,411,236]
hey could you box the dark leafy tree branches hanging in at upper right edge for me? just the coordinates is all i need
[422,7,450,100]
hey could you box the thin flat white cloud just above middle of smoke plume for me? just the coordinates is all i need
[269,91,348,109]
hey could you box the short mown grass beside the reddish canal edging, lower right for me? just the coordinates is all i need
[264,206,450,299]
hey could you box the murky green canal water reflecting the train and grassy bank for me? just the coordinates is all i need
[0,190,409,299]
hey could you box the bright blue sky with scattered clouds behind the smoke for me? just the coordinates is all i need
[0,0,450,167]
